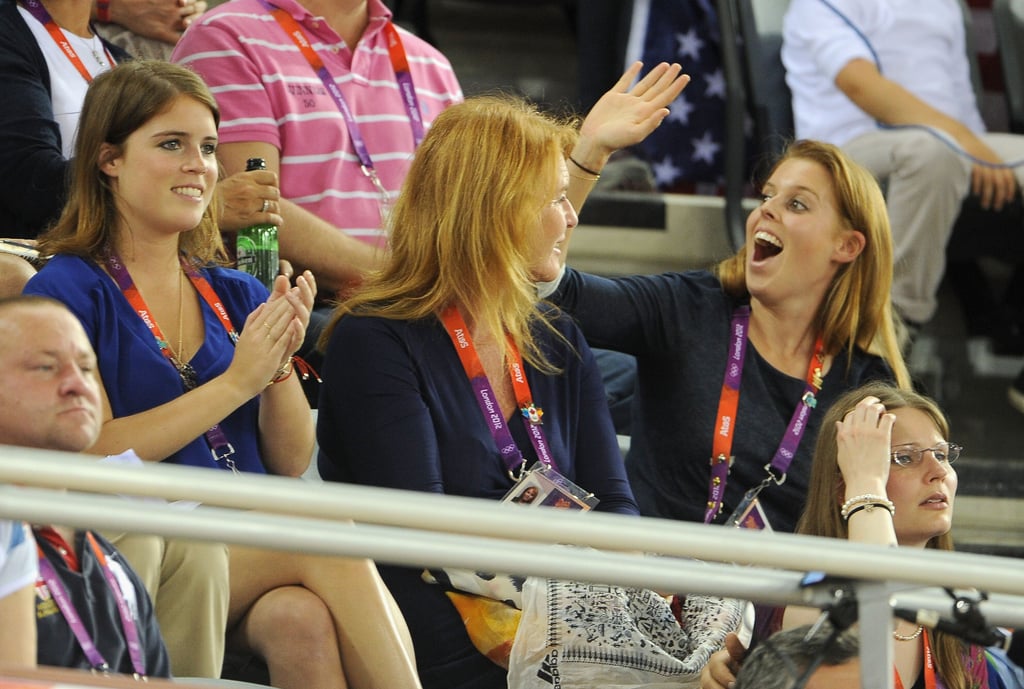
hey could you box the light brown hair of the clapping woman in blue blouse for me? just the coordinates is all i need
[39,59,227,264]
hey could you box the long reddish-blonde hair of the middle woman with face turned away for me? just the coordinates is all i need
[319,95,578,372]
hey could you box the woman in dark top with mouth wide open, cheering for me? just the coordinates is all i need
[551,141,909,531]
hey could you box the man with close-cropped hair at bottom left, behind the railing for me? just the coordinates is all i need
[0,297,170,677]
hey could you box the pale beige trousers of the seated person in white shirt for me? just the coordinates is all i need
[843,129,1024,322]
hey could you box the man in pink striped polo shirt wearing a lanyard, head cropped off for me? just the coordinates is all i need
[173,0,462,292]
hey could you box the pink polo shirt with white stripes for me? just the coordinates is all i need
[172,0,462,245]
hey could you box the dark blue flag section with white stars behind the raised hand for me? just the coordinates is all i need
[637,0,750,193]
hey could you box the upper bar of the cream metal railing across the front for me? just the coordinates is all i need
[0,445,1024,595]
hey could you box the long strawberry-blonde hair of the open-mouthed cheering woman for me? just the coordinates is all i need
[715,140,910,388]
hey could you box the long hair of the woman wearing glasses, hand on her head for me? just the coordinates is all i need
[797,382,971,689]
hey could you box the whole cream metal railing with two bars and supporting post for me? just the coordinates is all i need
[0,445,1024,688]
